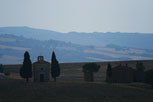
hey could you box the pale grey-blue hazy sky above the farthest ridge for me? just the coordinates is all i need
[0,0,153,33]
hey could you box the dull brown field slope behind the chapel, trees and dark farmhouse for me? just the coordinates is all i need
[4,60,153,81]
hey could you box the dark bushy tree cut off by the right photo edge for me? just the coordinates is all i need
[145,69,153,88]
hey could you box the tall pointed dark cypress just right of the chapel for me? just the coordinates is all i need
[51,51,60,82]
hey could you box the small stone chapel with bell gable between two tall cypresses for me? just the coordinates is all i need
[33,56,50,82]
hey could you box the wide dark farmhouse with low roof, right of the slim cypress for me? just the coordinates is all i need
[110,65,135,83]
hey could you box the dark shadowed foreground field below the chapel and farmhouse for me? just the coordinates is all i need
[0,76,153,102]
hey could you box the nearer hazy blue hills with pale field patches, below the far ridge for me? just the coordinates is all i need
[0,34,153,64]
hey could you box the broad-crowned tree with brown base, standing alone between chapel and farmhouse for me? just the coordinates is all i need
[83,63,100,81]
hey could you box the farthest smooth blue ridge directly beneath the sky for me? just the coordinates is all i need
[0,27,153,49]
